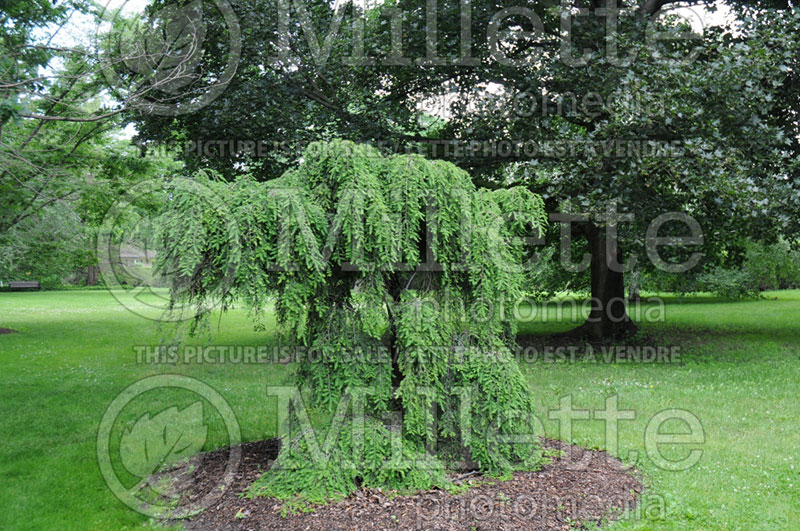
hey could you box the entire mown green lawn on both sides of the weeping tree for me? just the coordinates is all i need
[0,291,800,529]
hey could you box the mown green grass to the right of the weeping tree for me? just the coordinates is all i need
[523,291,800,529]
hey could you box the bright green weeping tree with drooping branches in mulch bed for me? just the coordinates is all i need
[159,141,546,499]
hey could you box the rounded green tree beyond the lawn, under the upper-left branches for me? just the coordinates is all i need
[0,131,181,287]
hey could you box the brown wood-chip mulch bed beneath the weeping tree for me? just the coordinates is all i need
[173,439,642,530]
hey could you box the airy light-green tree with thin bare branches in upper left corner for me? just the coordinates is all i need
[0,0,220,238]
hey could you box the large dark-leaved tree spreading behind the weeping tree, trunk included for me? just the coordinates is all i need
[131,0,798,337]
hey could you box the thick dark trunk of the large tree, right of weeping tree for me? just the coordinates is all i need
[563,223,638,339]
